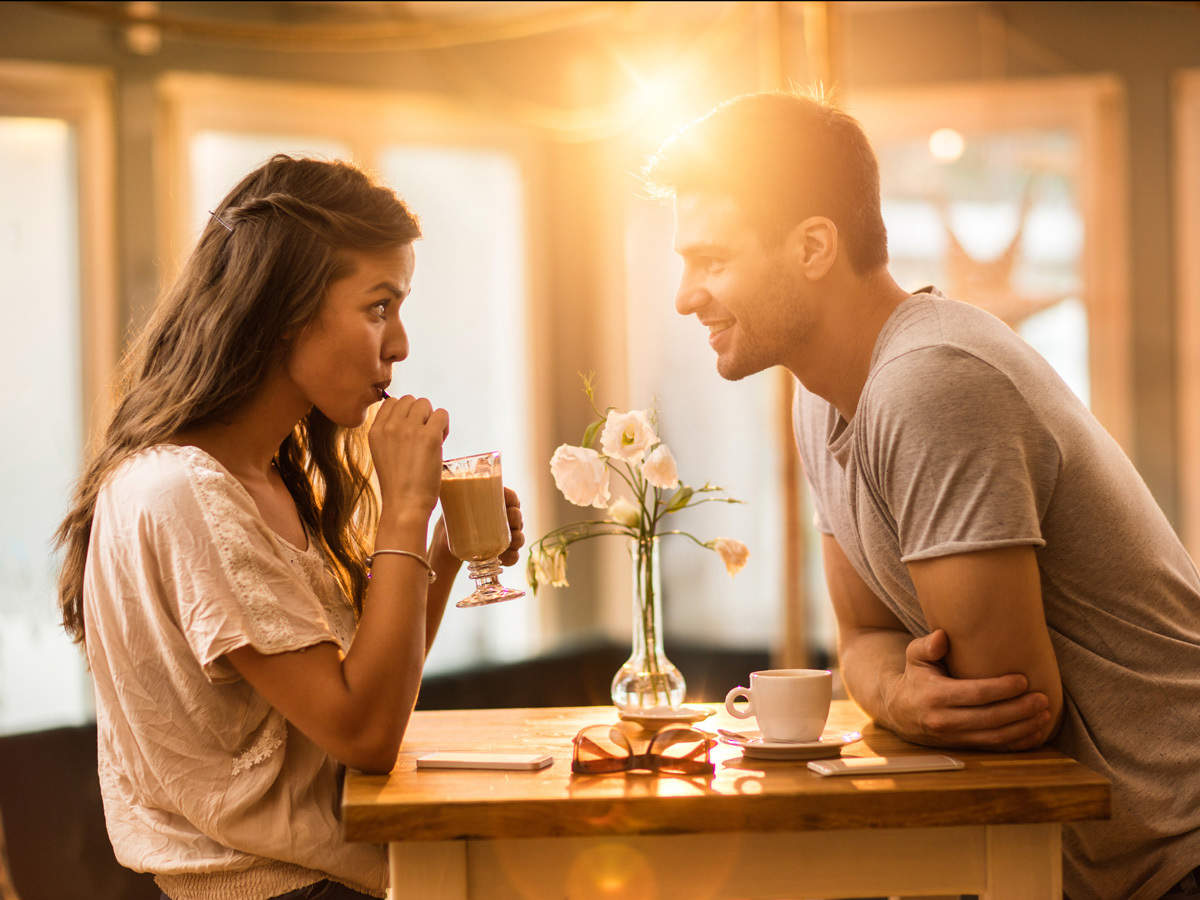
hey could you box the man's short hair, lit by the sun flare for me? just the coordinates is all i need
[643,91,888,275]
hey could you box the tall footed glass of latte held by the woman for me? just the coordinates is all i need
[440,450,524,606]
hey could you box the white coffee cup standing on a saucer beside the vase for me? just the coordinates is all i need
[725,668,833,742]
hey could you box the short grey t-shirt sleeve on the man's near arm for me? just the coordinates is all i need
[858,346,1061,563]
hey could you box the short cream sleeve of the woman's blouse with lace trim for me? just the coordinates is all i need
[143,466,347,682]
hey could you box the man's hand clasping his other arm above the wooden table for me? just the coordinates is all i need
[882,629,1050,750]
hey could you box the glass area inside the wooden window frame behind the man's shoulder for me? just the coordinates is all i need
[876,128,1091,403]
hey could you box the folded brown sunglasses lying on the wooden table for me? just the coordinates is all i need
[571,722,716,775]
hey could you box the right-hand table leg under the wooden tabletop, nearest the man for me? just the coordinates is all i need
[980,822,1062,900]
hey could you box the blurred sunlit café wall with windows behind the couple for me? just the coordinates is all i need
[0,2,1200,732]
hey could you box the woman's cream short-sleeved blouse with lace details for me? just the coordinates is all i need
[84,444,386,900]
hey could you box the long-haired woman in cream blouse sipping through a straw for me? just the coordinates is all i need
[58,156,524,900]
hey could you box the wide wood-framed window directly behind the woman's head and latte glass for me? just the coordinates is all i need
[162,74,545,673]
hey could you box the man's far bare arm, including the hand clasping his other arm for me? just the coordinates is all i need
[822,535,1062,750]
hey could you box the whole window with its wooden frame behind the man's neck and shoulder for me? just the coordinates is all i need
[848,77,1132,449]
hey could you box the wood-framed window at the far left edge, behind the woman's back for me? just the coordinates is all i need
[0,64,115,733]
